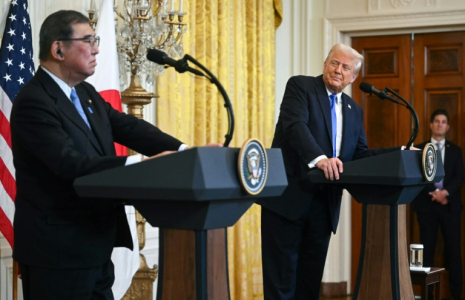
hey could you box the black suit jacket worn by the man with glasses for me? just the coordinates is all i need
[10,68,181,269]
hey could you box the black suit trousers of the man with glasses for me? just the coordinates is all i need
[18,260,115,300]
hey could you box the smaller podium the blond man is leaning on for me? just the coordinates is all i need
[308,150,444,300]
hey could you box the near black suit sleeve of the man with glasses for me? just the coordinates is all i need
[12,86,126,180]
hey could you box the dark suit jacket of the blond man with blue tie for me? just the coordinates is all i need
[258,75,399,232]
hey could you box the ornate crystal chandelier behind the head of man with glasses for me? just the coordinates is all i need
[87,0,187,86]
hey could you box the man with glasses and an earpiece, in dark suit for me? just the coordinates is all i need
[11,11,219,300]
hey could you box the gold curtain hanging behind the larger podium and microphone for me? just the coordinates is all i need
[157,0,282,300]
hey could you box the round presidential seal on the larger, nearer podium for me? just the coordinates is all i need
[238,139,268,195]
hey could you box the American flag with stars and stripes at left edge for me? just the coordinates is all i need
[0,0,34,248]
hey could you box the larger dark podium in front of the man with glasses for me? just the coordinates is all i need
[74,147,287,300]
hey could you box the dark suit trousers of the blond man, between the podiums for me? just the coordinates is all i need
[261,192,332,300]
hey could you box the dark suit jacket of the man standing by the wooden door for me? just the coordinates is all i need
[412,140,463,214]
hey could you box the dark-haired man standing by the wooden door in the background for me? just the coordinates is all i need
[412,109,463,299]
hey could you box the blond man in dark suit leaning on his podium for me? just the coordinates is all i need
[259,44,400,300]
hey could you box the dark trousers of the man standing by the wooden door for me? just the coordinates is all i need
[417,204,462,299]
